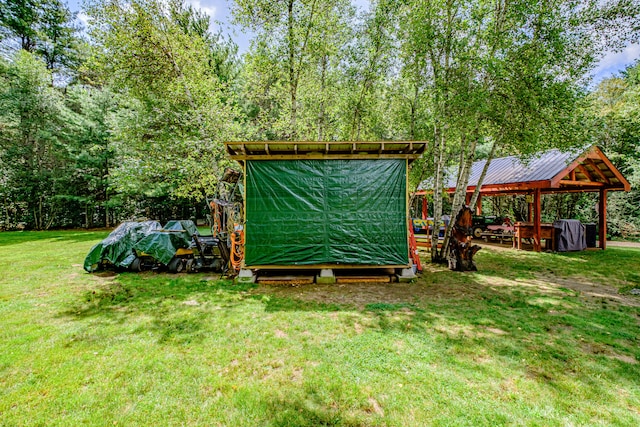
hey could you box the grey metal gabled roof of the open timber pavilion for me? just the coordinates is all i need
[420,146,630,194]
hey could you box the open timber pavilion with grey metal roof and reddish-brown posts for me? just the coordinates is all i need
[417,146,630,251]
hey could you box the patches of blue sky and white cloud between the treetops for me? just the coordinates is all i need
[68,0,640,84]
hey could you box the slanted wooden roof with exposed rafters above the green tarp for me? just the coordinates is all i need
[225,141,427,162]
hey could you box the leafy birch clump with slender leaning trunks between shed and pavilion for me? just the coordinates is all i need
[400,0,638,261]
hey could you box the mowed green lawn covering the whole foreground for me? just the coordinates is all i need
[0,231,640,426]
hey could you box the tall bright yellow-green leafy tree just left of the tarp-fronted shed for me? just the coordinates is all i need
[89,0,241,199]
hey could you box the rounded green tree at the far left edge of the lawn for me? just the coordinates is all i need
[0,50,67,229]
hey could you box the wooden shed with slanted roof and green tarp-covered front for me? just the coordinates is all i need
[225,141,426,284]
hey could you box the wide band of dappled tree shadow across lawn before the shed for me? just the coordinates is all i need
[63,247,640,384]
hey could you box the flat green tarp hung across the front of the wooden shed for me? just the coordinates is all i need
[245,159,409,266]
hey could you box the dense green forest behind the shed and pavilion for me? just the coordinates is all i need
[0,0,640,246]
